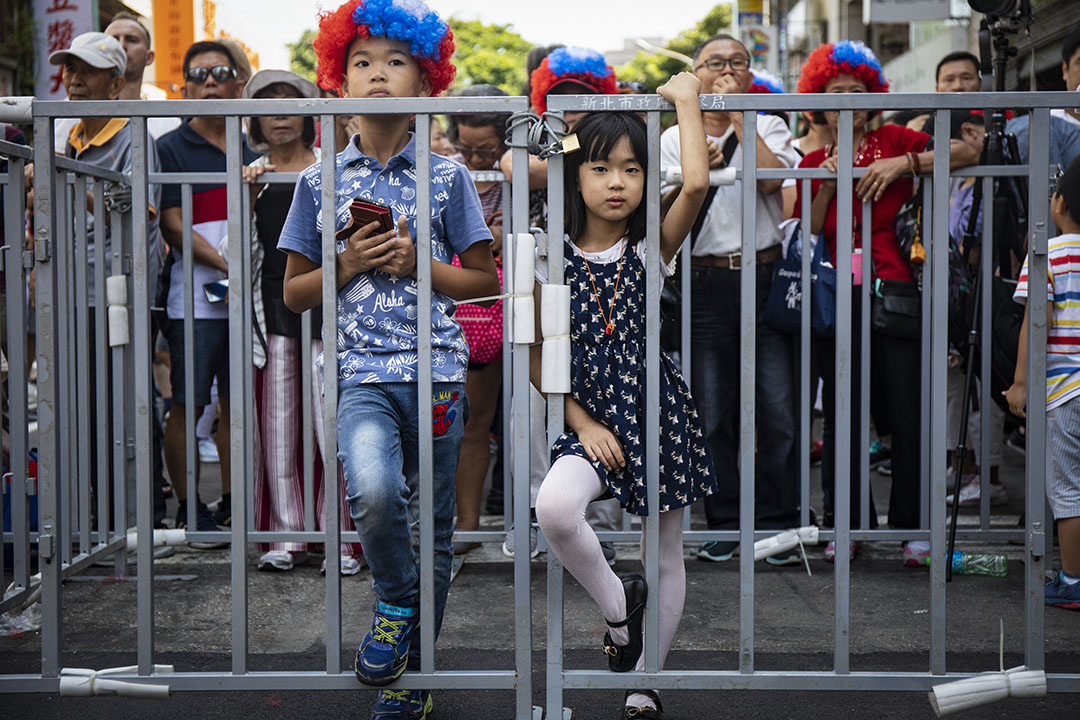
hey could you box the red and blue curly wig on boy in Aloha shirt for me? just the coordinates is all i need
[312,0,457,96]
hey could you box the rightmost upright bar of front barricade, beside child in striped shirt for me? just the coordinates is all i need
[1024,109,1053,670]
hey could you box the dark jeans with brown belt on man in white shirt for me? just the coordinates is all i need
[690,263,799,530]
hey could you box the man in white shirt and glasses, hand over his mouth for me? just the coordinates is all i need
[660,35,799,565]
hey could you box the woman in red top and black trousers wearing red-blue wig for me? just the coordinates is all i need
[795,40,978,567]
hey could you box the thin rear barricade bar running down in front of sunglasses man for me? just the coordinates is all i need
[180,182,196,530]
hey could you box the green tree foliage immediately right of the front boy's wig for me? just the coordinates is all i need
[450,17,532,95]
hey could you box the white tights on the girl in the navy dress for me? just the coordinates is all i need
[536,456,686,707]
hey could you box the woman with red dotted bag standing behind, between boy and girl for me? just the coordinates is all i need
[447,85,510,555]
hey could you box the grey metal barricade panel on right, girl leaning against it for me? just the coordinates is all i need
[546,93,1080,717]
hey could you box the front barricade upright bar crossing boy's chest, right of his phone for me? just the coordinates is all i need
[416,116,435,674]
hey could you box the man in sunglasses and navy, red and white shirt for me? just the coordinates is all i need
[158,41,258,548]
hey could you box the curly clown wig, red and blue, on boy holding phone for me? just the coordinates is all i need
[312,0,457,96]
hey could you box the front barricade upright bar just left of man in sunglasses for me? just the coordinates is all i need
[129,118,155,675]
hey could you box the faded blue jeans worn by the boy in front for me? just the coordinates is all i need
[338,382,469,643]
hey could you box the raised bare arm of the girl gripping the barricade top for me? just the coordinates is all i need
[657,72,708,264]
